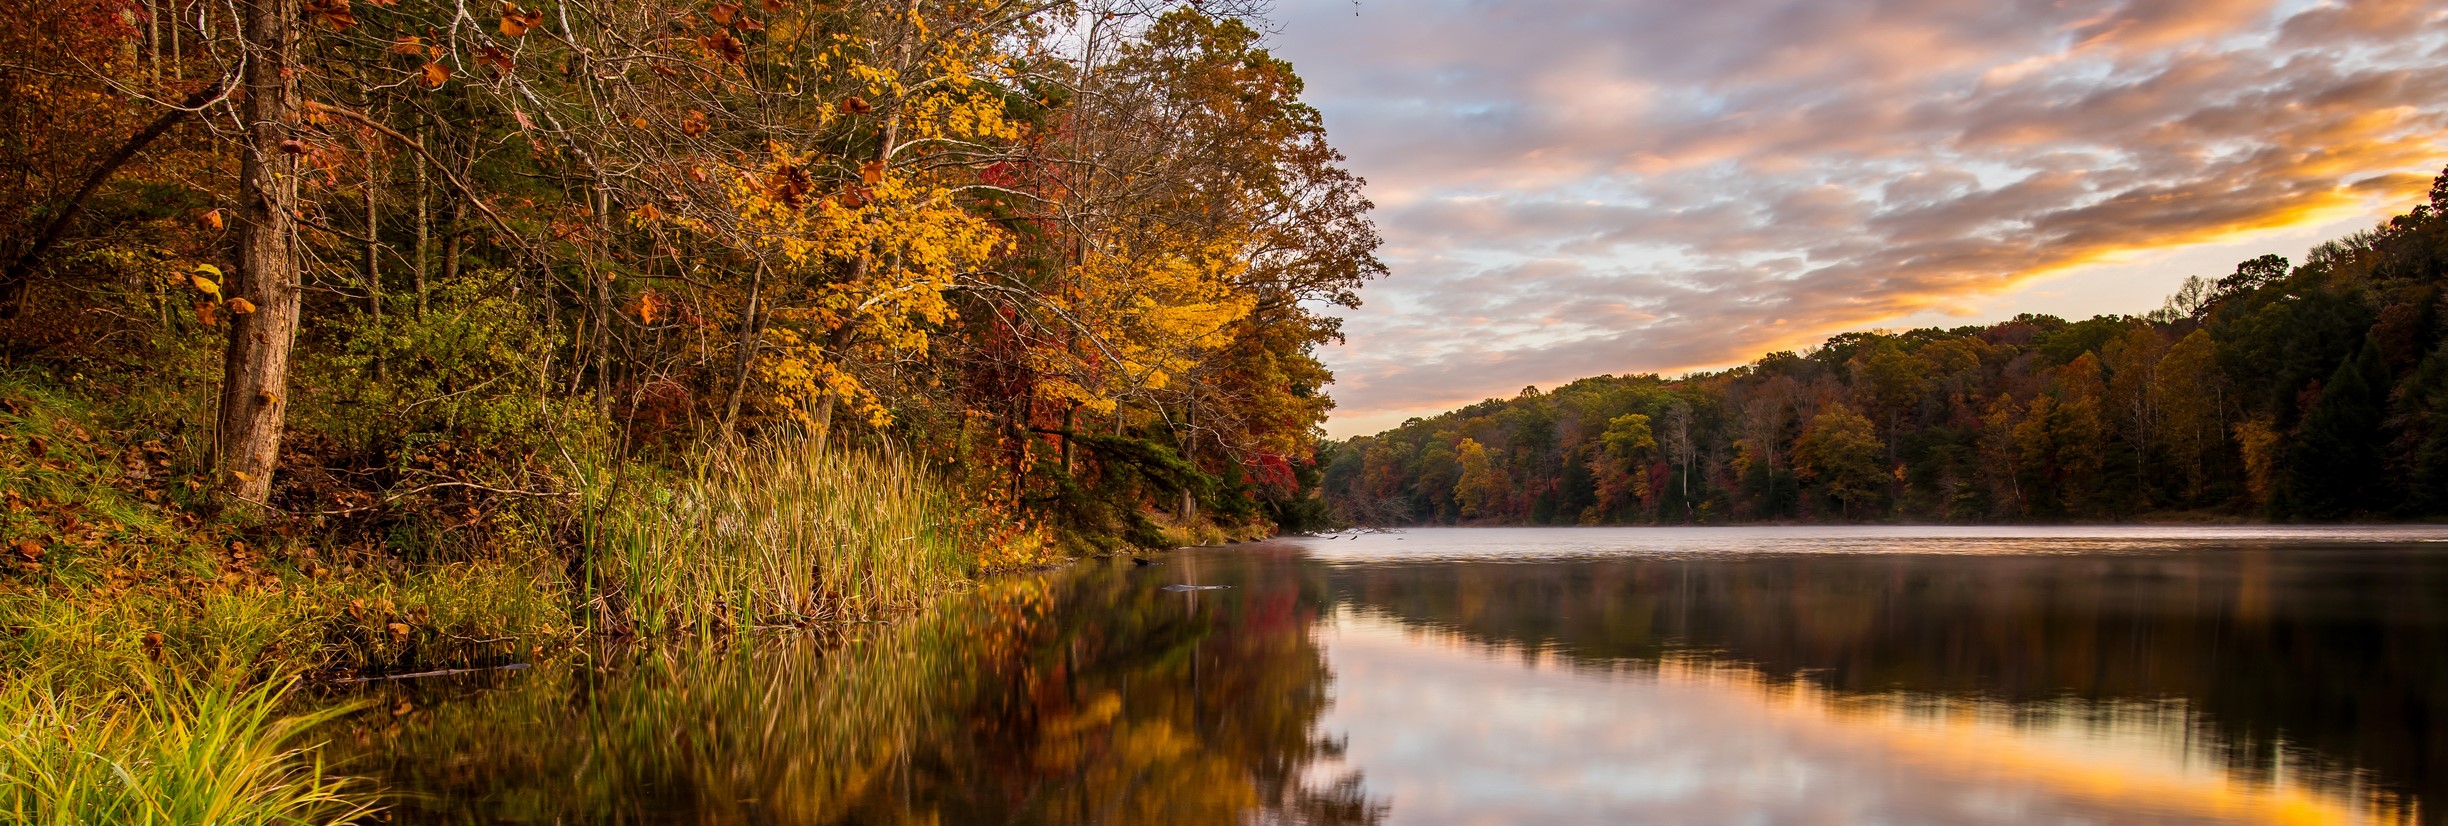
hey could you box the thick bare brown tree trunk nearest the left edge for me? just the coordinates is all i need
[215,0,301,502]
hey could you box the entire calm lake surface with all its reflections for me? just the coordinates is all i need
[335,527,2448,824]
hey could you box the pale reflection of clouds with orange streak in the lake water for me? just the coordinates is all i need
[1319,610,2372,824]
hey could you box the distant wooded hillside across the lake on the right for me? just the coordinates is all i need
[1322,172,2448,525]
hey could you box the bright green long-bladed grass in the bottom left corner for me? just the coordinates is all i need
[0,666,375,826]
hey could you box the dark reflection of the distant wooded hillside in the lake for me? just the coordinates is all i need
[1329,547,2448,819]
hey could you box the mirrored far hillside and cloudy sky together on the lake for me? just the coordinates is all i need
[1312,532,2448,824]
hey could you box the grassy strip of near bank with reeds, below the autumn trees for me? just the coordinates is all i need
[0,373,1045,824]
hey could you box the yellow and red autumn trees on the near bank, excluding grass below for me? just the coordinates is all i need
[0,0,1383,549]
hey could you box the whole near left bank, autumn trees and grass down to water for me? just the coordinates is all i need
[0,0,1386,824]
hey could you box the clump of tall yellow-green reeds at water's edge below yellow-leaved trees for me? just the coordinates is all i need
[588,439,979,632]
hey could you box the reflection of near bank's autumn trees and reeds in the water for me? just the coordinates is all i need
[335,553,1386,824]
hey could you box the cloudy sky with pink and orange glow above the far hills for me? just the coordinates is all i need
[1273,0,2448,436]
